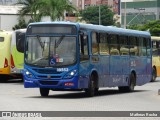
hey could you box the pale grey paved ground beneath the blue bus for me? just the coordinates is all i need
[0,78,160,120]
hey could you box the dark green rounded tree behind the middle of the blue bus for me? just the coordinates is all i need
[80,5,115,26]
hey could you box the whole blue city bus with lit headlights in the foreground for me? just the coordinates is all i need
[23,22,152,97]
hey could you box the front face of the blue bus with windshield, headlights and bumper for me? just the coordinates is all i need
[24,24,78,96]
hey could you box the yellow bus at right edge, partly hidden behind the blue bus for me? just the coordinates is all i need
[151,36,160,82]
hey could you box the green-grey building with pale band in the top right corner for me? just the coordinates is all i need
[121,0,160,28]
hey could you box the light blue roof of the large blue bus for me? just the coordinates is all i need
[29,21,150,37]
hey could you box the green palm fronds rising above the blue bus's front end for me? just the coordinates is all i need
[16,0,76,21]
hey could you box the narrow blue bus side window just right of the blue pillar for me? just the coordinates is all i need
[92,32,99,55]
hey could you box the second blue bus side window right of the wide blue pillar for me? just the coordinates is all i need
[99,33,109,55]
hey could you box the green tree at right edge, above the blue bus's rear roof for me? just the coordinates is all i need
[128,20,160,36]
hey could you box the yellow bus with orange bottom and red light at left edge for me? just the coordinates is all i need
[0,30,12,80]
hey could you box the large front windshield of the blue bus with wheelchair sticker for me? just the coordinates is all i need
[25,36,76,67]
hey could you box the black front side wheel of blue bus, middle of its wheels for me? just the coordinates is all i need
[85,75,95,97]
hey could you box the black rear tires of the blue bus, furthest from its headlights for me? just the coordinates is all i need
[118,73,136,92]
